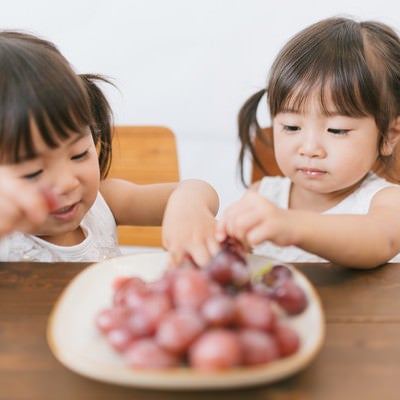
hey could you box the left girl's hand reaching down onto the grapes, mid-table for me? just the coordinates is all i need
[162,181,220,267]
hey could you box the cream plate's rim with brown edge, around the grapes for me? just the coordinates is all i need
[46,251,326,391]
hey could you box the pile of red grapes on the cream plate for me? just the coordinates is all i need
[96,241,307,370]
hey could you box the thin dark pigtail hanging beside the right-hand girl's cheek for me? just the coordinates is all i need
[238,89,267,186]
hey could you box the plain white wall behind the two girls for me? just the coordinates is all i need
[0,0,400,212]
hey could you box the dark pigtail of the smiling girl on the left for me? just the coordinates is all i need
[79,74,113,179]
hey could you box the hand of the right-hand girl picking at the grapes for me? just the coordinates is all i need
[216,191,294,247]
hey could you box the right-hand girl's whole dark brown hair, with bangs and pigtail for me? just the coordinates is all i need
[238,18,400,183]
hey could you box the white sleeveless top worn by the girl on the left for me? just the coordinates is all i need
[0,193,121,262]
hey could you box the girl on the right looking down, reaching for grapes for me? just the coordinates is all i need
[217,18,400,268]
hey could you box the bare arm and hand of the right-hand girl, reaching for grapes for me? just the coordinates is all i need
[217,187,400,268]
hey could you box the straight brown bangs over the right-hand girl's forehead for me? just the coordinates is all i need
[268,18,379,117]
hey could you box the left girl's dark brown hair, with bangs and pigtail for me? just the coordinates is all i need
[0,31,112,178]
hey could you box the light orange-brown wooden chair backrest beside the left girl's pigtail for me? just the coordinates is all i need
[108,126,179,246]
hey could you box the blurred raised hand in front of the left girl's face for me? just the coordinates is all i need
[0,166,55,237]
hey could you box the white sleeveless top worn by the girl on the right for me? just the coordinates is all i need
[253,172,400,262]
